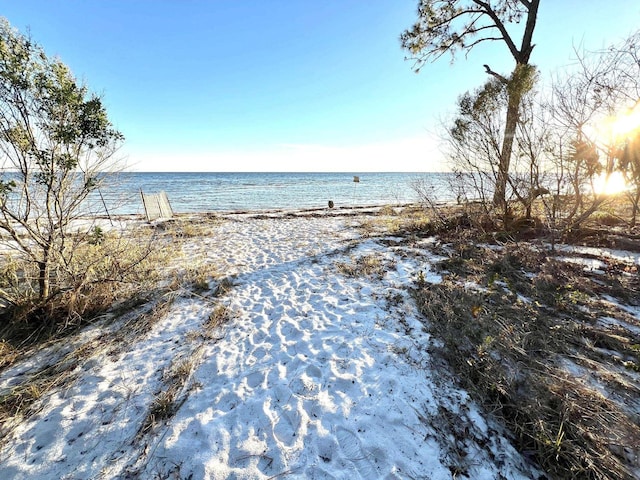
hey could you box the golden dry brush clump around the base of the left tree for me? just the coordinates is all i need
[0,229,171,349]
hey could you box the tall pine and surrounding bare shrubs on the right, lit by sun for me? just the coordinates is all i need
[401,5,640,236]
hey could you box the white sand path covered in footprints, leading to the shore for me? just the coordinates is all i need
[0,217,537,480]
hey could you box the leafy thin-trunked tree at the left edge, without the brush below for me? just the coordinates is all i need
[0,19,122,300]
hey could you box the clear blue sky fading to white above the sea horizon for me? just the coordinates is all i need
[0,0,640,172]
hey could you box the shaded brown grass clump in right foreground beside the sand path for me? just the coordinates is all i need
[414,245,640,479]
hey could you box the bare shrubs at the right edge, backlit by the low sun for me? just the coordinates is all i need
[530,32,640,238]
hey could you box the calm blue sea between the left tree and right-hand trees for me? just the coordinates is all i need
[92,172,453,214]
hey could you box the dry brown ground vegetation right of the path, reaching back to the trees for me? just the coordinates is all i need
[350,201,640,480]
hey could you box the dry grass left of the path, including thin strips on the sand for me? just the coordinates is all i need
[0,214,238,458]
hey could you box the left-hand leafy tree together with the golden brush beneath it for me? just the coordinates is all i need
[0,19,182,346]
